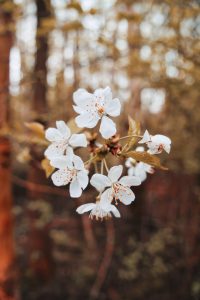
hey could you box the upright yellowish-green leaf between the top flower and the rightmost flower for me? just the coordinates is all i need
[122,116,140,152]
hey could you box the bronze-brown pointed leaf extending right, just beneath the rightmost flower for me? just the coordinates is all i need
[123,151,168,170]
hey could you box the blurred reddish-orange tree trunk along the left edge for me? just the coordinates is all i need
[0,7,16,300]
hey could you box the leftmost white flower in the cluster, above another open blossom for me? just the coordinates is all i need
[44,121,87,160]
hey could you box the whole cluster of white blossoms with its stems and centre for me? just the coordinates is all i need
[44,87,171,219]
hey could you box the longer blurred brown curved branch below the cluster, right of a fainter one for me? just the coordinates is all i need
[90,219,115,299]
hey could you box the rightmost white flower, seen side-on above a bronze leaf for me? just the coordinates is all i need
[138,130,171,154]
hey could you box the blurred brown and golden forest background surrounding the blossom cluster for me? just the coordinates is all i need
[0,0,200,300]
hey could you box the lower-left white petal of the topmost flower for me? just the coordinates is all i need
[75,112,99,128]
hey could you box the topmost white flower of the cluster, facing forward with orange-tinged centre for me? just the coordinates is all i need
[73,87,121,139]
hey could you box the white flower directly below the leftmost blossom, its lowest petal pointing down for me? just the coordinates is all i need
[51,155,88,198]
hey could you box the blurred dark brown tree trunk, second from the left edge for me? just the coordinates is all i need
[28,0,52,280]
